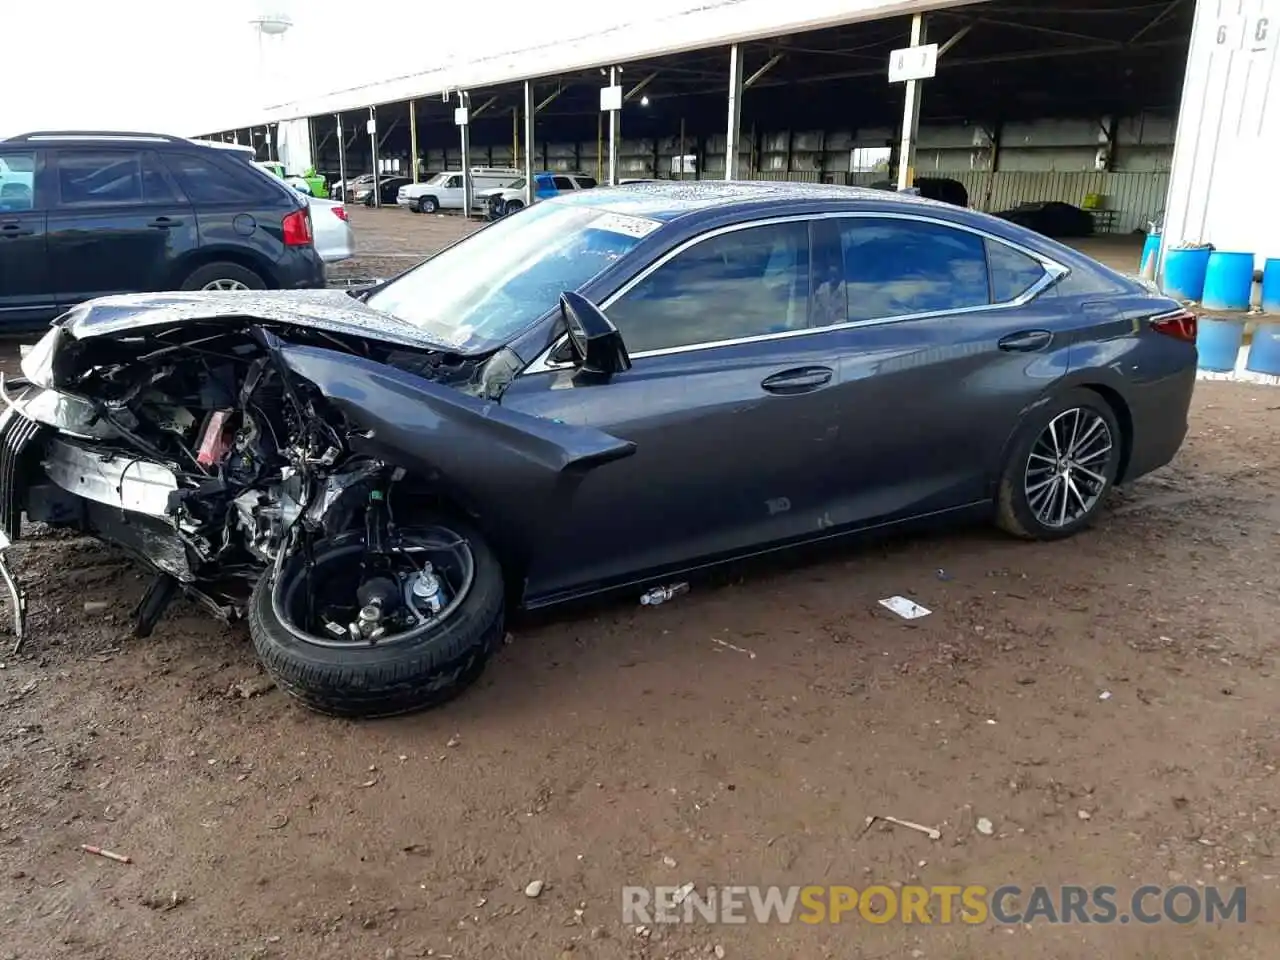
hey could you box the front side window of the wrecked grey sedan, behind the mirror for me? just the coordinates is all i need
[607,221,809,353]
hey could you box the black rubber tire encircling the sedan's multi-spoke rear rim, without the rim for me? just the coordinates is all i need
[996,388,1124,540]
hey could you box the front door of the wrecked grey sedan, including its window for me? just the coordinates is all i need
[503,220,840,595]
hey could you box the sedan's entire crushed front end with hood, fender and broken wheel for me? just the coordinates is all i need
[0,291,635,717]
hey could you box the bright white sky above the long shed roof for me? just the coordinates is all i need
[0,0,705,137]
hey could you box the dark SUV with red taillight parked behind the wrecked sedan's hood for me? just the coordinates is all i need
[0,132,325,329]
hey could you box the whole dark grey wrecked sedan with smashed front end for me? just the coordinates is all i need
[0,182,1196,716]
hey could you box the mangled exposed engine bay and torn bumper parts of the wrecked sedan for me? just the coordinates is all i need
[8,321,494,643]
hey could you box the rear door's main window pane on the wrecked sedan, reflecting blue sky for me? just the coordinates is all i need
[841,218,991,321]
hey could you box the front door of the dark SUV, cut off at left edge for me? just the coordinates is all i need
[0,145,58,326]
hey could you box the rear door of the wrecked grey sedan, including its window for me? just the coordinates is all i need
[814,216,1070,529]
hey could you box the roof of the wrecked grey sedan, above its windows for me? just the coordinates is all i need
[548,180,963,221]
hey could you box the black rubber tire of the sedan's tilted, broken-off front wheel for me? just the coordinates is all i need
[248,517,506,718]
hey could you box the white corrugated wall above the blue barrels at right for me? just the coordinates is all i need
[1165,0,1280,266]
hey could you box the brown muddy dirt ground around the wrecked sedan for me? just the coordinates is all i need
[0,210,1280,960]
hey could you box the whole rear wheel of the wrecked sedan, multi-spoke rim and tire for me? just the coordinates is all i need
[996,389,1123,540]
